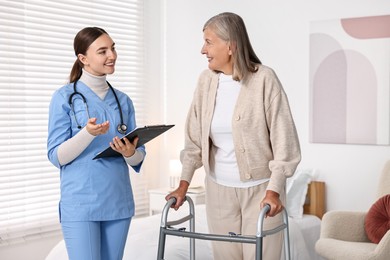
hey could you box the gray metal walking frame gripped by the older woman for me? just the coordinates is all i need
[157,196,290,260]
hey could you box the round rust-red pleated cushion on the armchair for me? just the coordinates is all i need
[364,194,390,244]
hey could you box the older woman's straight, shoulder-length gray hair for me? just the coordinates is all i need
[203,12,261,81]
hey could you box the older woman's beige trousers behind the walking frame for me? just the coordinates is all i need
[206,177,285,260]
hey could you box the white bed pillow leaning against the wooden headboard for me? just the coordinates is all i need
[286,169,313,218]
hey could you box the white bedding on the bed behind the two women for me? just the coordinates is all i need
[46,205,322,260]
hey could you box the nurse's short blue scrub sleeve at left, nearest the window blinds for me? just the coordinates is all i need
[47,90,72,168]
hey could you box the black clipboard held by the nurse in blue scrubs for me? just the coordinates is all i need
[93,125,175,160]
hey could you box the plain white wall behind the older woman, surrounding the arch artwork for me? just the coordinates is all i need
[161,0,390,211]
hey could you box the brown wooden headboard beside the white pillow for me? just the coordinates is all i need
[303,181,325,219]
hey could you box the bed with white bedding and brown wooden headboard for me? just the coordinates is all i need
[46,172,325,260]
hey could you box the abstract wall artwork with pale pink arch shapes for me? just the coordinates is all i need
[310,15,390,145]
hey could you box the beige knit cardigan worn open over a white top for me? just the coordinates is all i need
[180,65,301,194]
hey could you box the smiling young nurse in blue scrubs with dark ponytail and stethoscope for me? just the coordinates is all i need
[47,27,146,260]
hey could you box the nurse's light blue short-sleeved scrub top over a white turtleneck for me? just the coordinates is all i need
[47,81,145,221]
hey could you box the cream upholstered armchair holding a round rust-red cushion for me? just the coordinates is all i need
[315,160,390,260]
